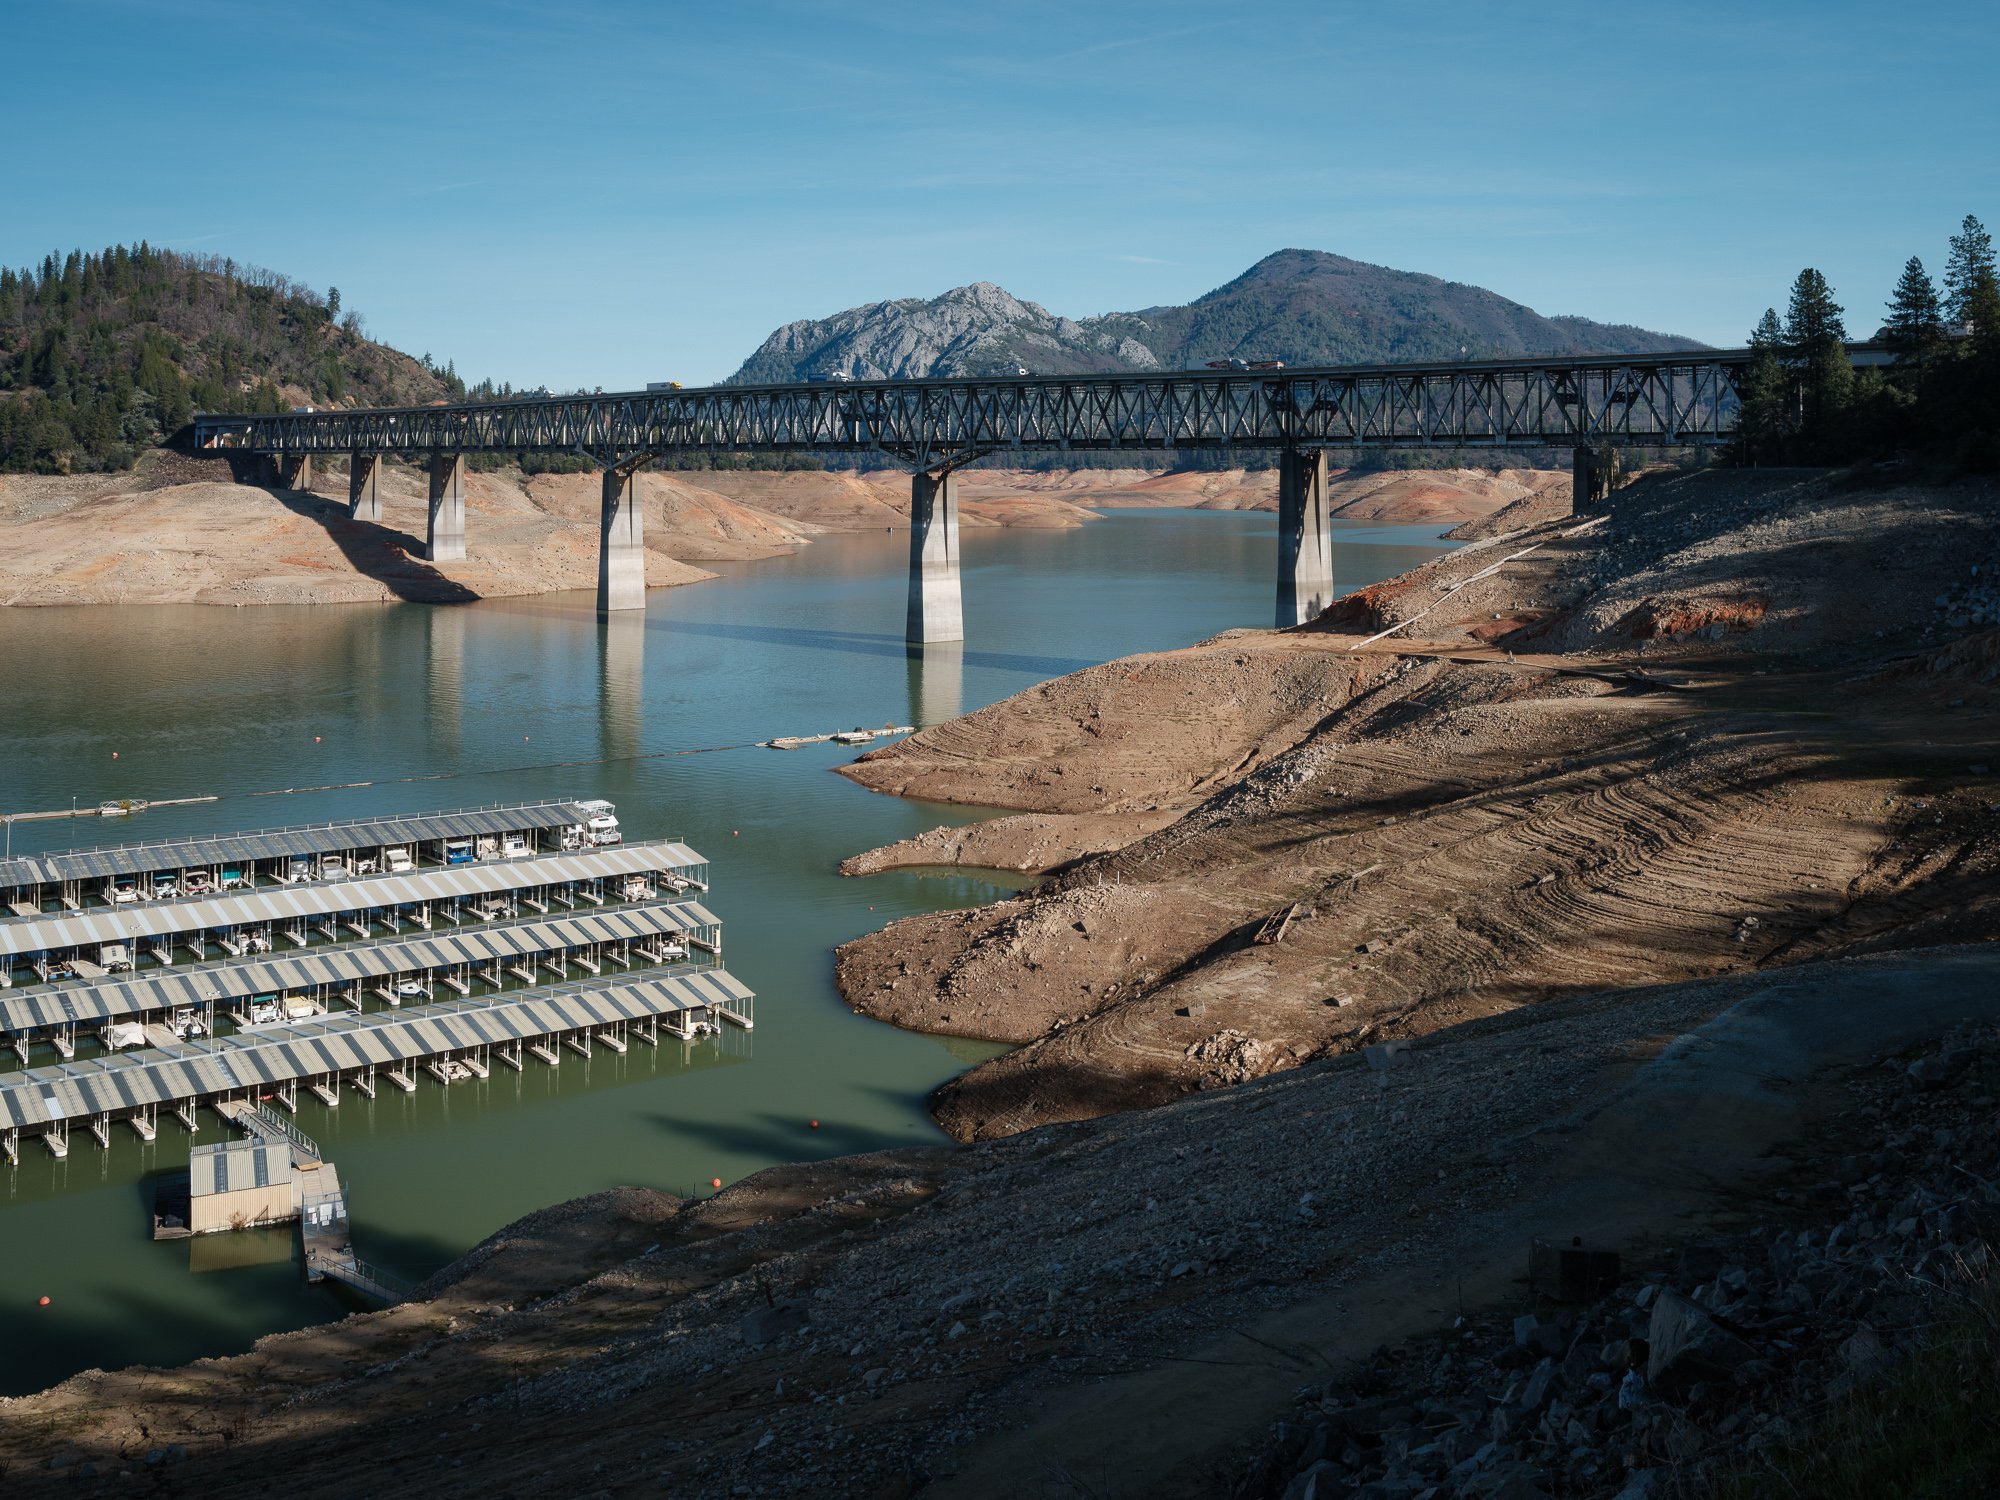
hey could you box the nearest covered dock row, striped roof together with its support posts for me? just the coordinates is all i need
[0,968,754,1160]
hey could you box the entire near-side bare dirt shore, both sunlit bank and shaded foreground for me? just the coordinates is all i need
[0,472,2000,1500]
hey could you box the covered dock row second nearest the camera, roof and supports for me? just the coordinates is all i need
[0,888,722,1078]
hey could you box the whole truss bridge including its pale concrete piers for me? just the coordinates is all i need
[194,344,1890,644]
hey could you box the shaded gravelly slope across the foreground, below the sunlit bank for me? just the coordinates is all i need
[0,948,1996,1500]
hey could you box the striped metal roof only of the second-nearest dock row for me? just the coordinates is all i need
[0,900,720,1034]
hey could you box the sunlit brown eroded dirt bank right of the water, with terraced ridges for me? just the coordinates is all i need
[838,472,2000,1140]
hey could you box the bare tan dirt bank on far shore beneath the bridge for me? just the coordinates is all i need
[0,452,1566,606]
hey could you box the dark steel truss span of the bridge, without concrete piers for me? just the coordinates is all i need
[196,350,1750,472]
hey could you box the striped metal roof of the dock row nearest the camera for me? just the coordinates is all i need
[0,968,752,1130]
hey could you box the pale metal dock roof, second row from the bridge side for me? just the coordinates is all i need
[0,842,706,958]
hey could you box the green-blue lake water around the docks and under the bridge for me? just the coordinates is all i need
[0,510,1442,1394]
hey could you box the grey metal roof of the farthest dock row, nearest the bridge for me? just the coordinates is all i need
[0,802,590,888]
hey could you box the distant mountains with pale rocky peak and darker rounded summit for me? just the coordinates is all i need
[732,250,1698,384]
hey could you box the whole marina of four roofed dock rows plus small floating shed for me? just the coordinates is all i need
[0,802,754,1228]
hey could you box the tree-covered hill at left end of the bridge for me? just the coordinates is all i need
[0,242,464,474]
